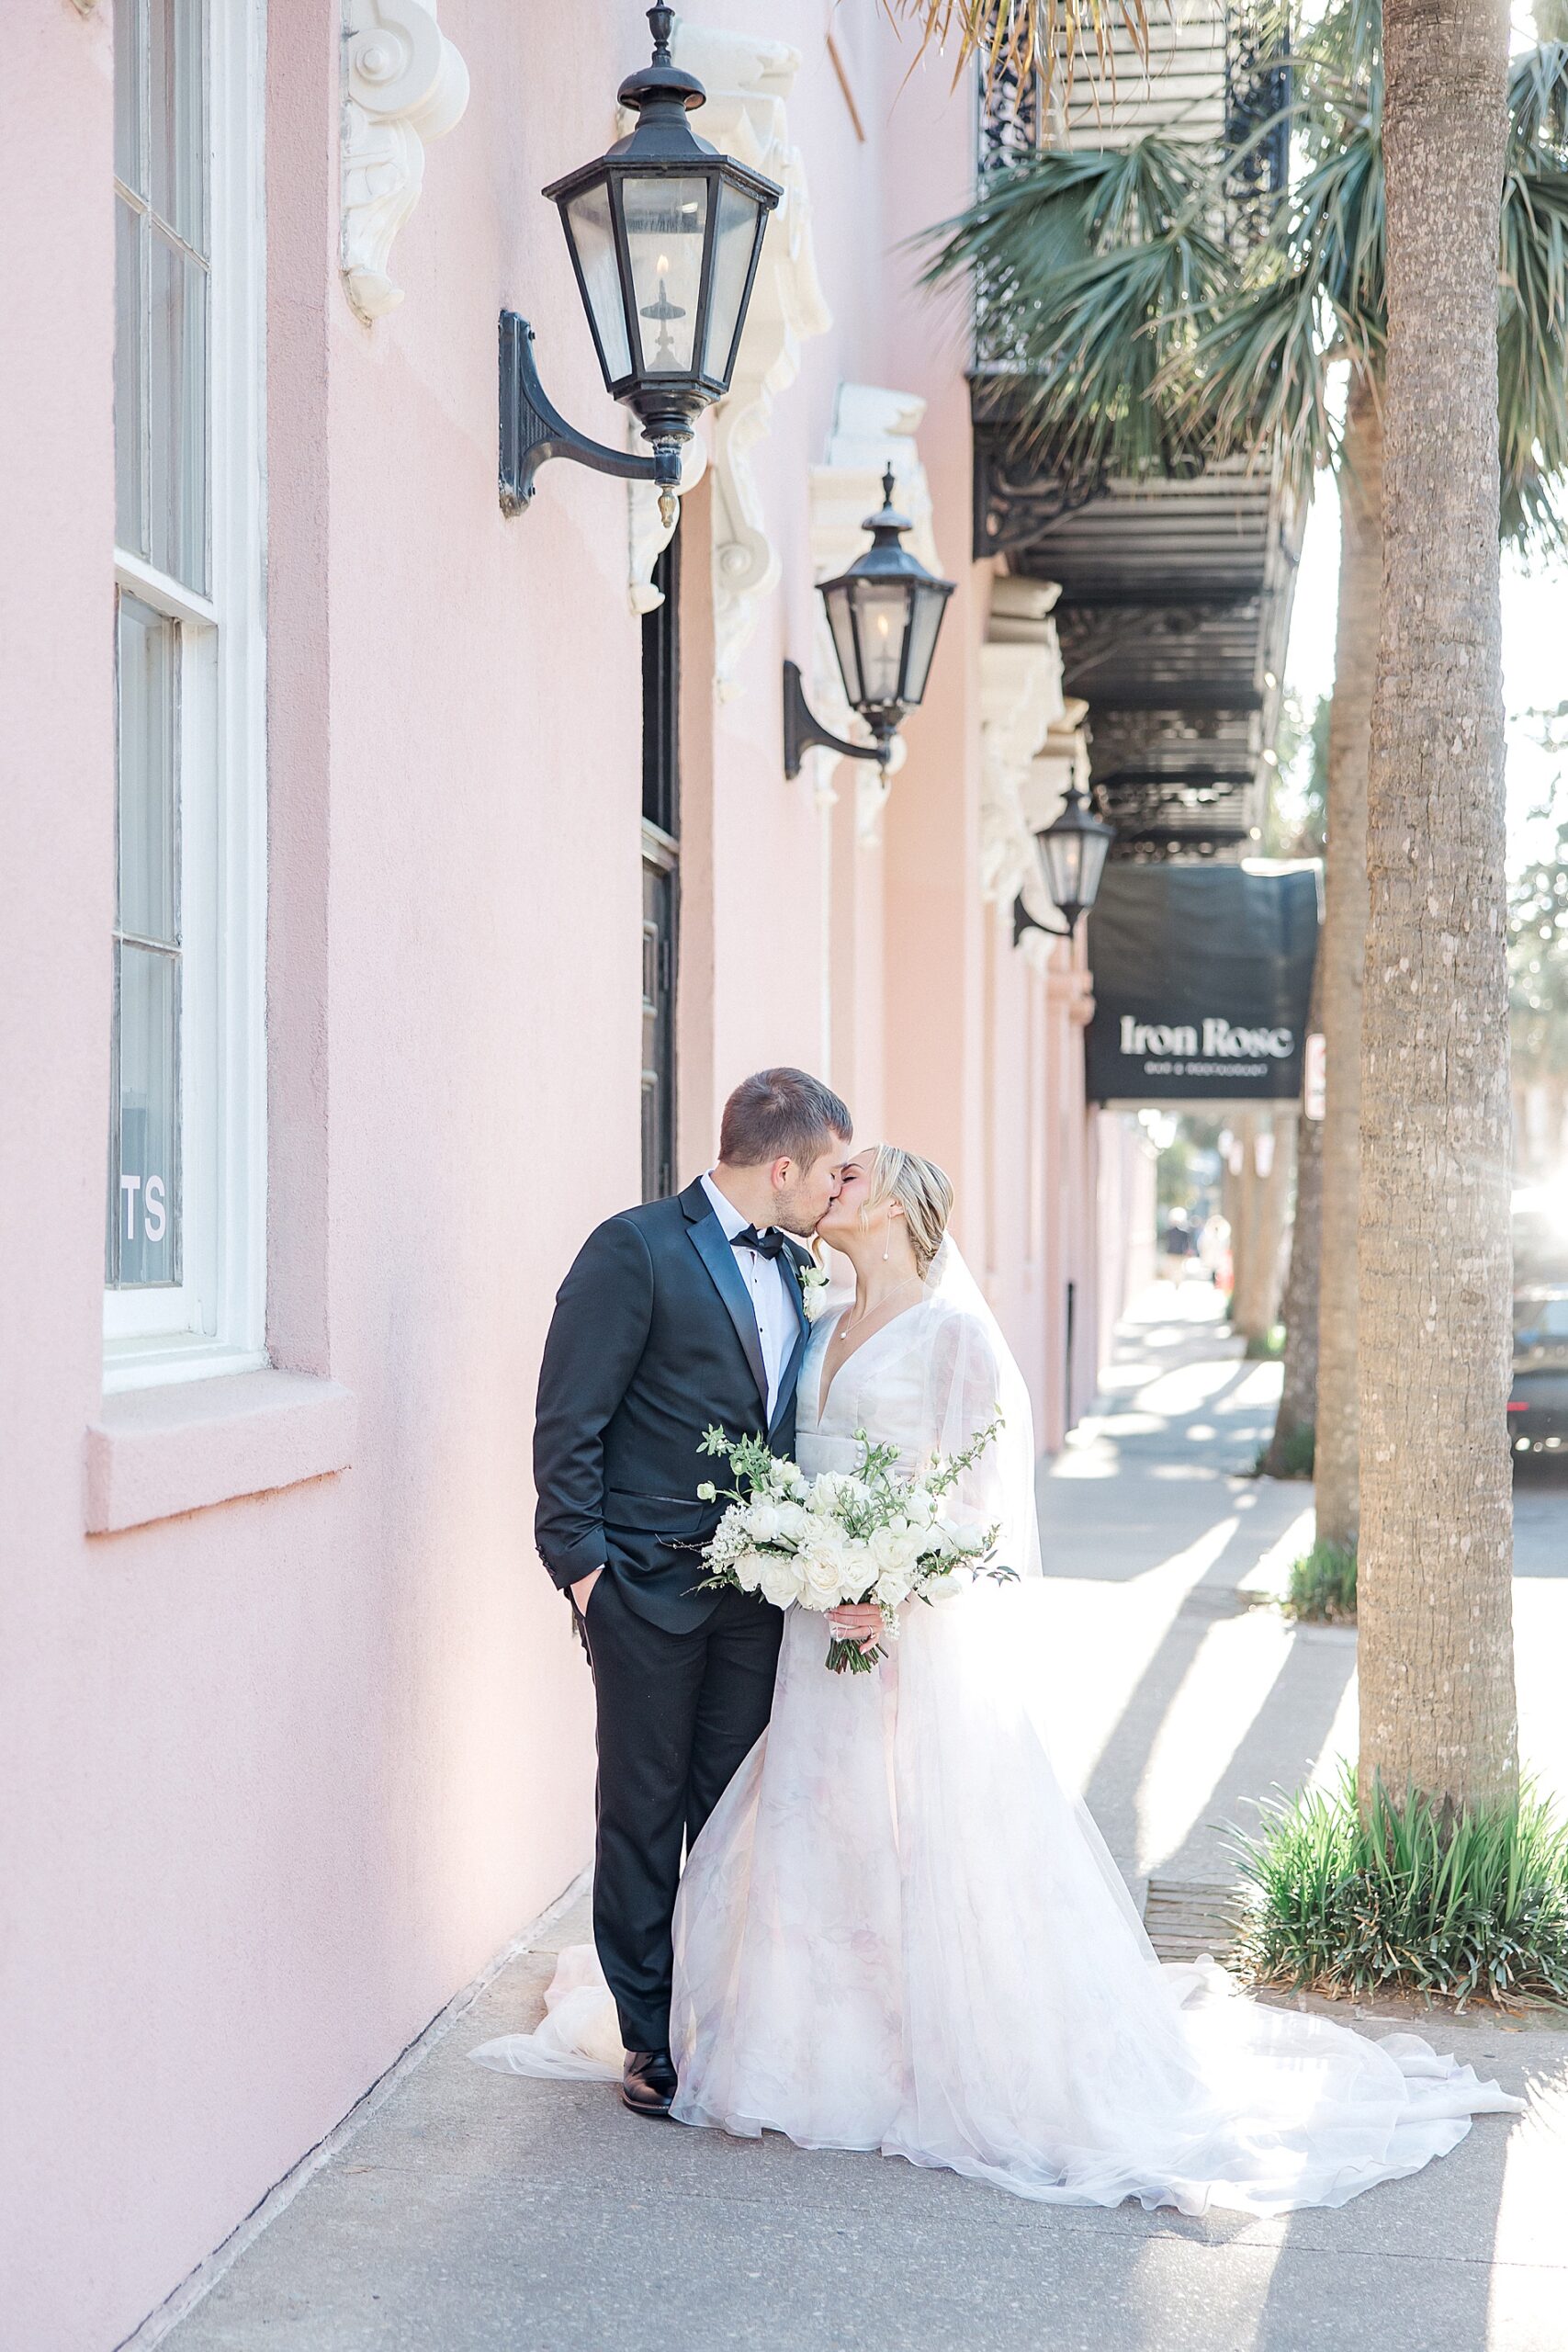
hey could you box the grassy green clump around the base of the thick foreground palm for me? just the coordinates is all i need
[1235,1767,1568,2002]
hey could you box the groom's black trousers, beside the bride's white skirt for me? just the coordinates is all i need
[583,1571,783,2051]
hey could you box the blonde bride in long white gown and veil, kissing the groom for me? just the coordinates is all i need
[475,1146,1521,2213]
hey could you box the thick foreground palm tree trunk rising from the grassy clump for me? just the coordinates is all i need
[1359,0,1518,1806]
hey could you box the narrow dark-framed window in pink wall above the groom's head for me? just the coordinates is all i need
[642,532,680,1200]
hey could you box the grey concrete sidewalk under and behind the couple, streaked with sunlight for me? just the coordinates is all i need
[164,1284,1568,2352]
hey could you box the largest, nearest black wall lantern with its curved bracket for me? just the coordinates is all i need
[501,7,783,526]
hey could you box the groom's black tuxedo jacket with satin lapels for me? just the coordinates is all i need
[534,1183,807,1633]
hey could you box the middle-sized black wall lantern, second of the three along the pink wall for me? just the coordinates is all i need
[785,466,954,776]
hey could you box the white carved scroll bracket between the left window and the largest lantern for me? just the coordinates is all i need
[341,0,468,324]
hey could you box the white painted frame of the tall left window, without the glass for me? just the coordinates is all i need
[104,0,268,1393]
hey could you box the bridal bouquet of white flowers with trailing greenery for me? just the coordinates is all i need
[698,1419,1013,1675]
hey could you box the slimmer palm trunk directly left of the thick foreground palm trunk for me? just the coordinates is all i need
[1314,374,1382,1543]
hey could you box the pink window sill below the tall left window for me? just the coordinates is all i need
[87,1369,357,1536]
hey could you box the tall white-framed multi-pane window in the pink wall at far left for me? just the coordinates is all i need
[104,0,264,1381]
